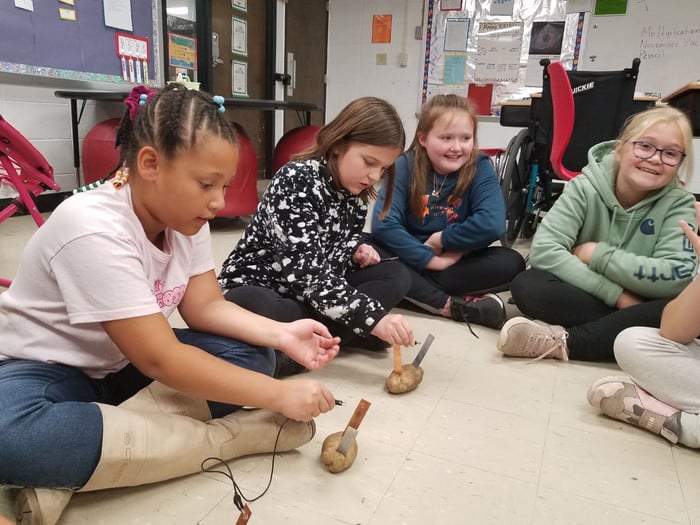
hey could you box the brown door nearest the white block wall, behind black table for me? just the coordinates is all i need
[284,0,328,132]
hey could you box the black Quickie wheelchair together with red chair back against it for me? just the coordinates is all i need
[498,58,655,246]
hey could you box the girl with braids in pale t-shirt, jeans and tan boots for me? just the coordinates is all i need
[0,85,339,524]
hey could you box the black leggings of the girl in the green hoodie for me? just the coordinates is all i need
[510,269,670,361]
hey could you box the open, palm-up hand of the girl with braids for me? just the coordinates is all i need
[277,319,340,370]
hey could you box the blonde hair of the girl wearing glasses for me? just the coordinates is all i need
[613,106,693,186]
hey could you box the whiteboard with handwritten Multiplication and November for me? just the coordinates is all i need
[579,0,700,96]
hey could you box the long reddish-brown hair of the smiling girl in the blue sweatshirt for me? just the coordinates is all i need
[409,95,479,217]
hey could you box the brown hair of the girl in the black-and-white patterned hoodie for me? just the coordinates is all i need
[292,97,406,217]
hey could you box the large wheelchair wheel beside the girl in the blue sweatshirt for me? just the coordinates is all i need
[499,129,533,247]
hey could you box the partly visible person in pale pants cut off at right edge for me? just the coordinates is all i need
[588,203,700,448]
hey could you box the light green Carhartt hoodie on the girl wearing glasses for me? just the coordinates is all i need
[530,141,697,306]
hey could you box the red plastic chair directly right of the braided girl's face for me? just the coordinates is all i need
[216,123,259,217]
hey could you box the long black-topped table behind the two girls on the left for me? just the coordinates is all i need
[54,90,323,187]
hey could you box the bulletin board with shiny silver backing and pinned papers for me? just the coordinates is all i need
[418,0,576,107]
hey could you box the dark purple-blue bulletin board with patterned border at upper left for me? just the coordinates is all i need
[0,0,162,85]
